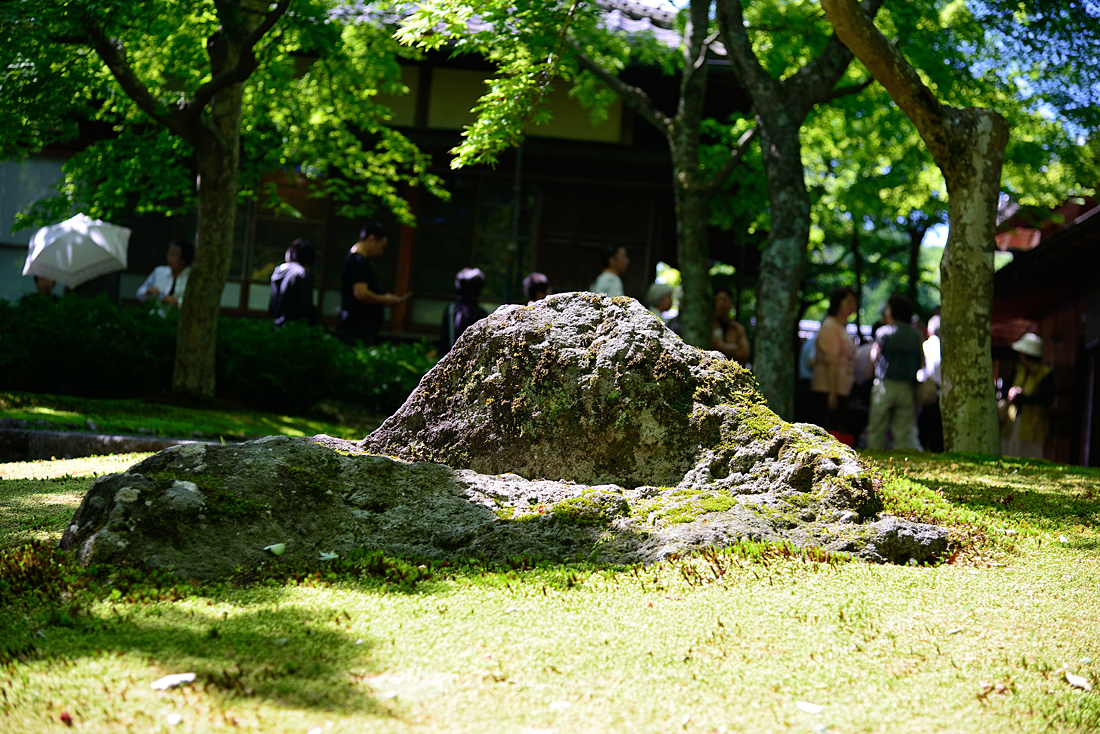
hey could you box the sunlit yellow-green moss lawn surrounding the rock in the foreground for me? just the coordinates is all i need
[0,453,1100,734]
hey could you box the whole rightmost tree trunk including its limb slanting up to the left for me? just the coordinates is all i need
[822,0,1009,454]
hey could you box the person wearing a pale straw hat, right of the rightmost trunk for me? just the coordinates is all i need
[998,333,1054,459]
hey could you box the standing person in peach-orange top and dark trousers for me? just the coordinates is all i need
[810,286,859,435]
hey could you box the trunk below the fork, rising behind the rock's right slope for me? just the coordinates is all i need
[754,120,810,420]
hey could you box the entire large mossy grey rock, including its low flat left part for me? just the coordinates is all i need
[62,294,947,579]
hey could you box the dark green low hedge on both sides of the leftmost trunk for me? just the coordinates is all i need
[0,295,435,414]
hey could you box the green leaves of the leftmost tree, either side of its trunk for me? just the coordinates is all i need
[0,0,447,227]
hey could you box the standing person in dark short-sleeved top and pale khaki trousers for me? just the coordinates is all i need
[867,294,924,450]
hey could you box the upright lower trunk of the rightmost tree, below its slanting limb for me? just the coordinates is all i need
[939,108,1009,454]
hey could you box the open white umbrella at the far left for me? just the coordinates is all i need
[23,213,130,288]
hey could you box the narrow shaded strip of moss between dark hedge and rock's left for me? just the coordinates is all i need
[0,392,376,439]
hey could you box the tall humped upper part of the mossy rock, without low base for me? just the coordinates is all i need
[360,293,882,517]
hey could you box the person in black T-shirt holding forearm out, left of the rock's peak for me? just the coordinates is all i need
[337,222,407,347]
